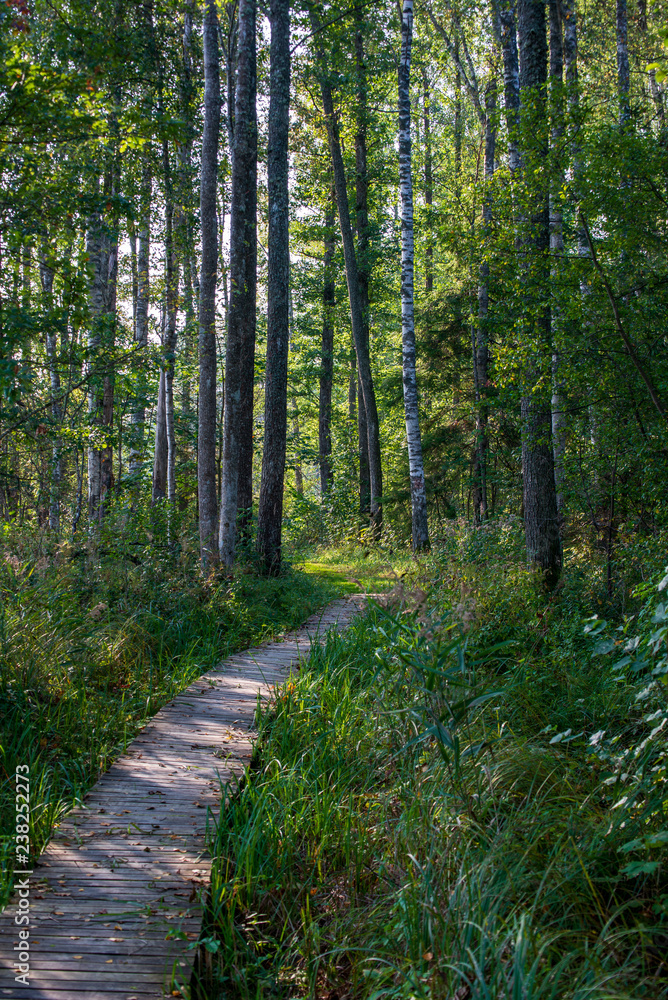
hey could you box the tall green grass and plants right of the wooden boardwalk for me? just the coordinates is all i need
[202,543,668,1000]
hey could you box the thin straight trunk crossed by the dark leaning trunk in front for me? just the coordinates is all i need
[354,17,371,520]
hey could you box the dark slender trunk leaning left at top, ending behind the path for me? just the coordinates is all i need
[310,10,383,537]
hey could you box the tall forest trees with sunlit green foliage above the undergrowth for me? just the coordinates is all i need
[0,0,668,586]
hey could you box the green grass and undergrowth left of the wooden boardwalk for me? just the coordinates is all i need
[0,526,338,905]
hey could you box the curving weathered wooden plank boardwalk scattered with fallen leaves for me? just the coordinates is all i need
[0,598,364,1000]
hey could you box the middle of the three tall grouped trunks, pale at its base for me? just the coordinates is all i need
[219,0,257,569]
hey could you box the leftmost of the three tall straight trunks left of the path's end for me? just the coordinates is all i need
[197,0,220,570]
